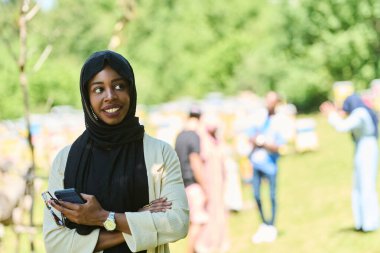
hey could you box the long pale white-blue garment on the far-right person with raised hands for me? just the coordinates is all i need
[329,108,379,231]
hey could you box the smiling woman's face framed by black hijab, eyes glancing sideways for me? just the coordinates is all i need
[88,66,130,125]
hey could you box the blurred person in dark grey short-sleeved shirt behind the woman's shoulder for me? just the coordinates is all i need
[175,106,209,253]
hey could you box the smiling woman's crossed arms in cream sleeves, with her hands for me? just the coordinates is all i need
[43,144,188,253]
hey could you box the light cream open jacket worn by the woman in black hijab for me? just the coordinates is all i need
[43,134,189,253]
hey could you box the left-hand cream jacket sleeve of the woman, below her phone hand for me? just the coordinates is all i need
[43,147,99,253]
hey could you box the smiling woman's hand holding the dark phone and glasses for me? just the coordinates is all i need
[50,193,108,226]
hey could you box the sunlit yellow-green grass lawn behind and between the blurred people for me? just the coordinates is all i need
[0,116,380,253]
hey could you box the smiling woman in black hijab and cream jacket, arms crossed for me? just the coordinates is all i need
[43,51,189,253]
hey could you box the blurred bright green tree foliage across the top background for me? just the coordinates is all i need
[0,0,380,119]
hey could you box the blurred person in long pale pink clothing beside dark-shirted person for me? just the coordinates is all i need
[194,113,229,253]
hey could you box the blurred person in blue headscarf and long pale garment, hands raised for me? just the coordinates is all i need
[320,94,379,232]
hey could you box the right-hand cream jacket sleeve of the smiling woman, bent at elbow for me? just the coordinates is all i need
[123,143,189,252]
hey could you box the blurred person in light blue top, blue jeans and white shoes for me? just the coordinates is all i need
[249,91,285,243]
